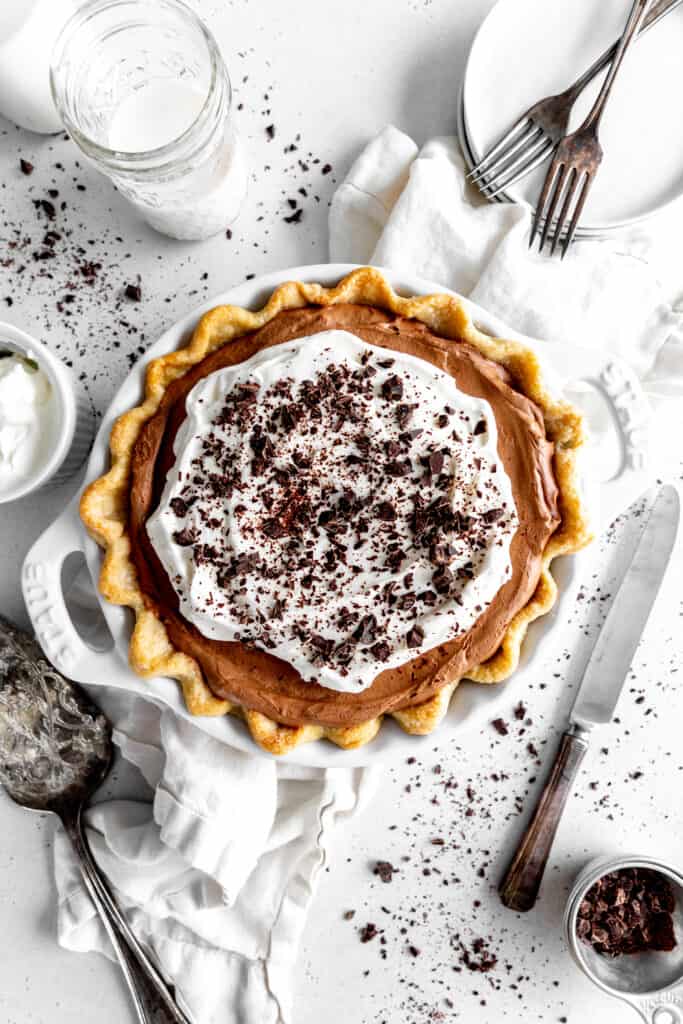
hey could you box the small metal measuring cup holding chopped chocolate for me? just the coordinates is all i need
[564,855,683,1024]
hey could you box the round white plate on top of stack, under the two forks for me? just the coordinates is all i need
[463,0,683,233]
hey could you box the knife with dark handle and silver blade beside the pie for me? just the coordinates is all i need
[499,485,680,910]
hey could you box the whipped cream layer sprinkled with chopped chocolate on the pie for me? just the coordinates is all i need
[146,331,518,692]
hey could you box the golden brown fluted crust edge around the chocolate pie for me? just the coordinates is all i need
[81,267,590,754]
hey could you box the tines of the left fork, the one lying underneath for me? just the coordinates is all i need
[467,115,554,199]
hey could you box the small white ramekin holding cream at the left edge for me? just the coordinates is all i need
[0,322,93,505]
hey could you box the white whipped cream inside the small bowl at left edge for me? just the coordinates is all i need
[0,350,53,489]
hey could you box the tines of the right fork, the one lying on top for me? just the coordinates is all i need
[528,156,593,259]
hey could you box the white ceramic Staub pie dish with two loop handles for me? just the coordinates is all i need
[23,264,648,766]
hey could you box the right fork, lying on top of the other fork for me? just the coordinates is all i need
[528,0,652,259]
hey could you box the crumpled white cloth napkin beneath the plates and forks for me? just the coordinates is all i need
[330,125,683,429]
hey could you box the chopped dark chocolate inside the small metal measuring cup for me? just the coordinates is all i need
[577,867,677,956]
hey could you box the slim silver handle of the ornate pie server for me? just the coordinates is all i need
[59,807,190,1024]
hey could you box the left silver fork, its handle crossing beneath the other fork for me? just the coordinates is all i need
[468,0,683,199]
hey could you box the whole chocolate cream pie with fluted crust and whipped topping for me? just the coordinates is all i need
[81,267,589,754]
